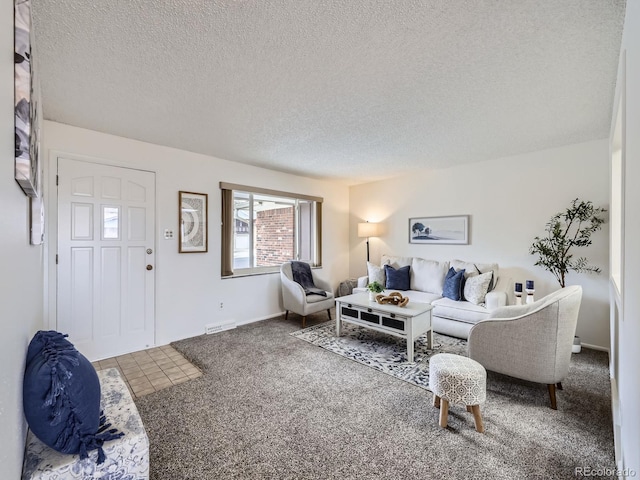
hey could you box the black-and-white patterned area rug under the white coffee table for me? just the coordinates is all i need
[290,321,467,390]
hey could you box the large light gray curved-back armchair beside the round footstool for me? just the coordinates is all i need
[468,286,582,410]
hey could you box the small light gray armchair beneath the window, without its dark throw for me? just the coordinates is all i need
[280,262,335,328]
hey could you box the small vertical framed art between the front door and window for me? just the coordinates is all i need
[178,192,208,253]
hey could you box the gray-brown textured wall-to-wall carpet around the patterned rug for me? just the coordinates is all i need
[136,312,614,480]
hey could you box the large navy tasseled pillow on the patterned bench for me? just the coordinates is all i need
[23,331,124,463]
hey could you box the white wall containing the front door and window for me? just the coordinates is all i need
[43,121,349,345]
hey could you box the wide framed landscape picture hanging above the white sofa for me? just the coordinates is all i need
[409,215,469,245]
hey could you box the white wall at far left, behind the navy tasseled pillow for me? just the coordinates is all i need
[0,0,43,478]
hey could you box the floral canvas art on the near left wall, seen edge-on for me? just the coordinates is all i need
[14,0,42,197]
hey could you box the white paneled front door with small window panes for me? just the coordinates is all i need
[57,158,155,361]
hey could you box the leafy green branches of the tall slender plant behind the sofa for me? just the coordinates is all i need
[529,198,607,288]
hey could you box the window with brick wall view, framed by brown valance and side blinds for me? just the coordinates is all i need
[220,183,322,277]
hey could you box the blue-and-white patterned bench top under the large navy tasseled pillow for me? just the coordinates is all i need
[22,368,149,480]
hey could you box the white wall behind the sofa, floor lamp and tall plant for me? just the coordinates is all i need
[350,140,609,348]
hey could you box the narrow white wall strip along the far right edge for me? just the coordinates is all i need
[612,1,640,476]
